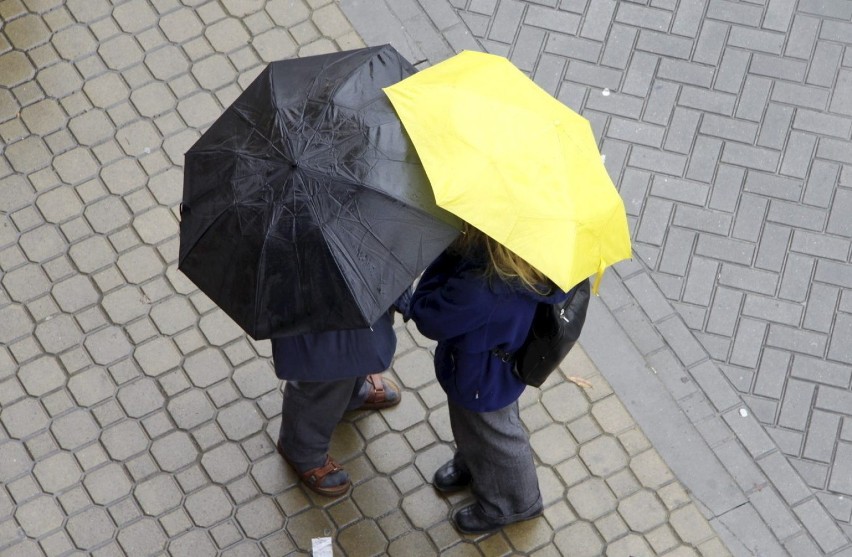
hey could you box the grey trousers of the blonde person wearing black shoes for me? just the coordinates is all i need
[449,401,542,524]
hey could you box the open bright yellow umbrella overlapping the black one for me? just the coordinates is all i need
[384,51,631,291]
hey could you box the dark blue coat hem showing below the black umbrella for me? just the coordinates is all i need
[272,312,396,381]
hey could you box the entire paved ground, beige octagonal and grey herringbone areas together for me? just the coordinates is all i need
[0,0,852,557]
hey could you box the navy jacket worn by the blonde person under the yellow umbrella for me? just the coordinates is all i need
[411,252,568,412]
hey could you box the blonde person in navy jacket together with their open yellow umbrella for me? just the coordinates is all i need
[384,52,631,534]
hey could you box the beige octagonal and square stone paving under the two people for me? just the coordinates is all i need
[0,0,729,557]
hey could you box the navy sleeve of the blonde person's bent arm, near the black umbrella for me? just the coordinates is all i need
[411,261,492,341]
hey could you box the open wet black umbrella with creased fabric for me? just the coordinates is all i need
[178,45,458,339]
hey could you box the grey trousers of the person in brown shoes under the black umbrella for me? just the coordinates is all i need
[279,377,369,471]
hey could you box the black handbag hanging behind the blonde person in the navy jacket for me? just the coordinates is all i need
[493,279,591,387]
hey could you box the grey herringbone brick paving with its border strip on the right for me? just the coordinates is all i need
[341,0,852,555]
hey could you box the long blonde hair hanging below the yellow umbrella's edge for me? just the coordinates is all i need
[453,223,553,294]
